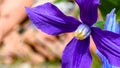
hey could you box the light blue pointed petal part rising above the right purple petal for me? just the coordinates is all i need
[105,9,120,34]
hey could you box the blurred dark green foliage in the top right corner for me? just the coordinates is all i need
[99,0,120,21]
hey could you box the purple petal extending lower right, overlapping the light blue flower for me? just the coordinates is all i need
[92,27,120,66]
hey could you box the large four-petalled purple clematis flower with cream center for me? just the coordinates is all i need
[26,0,120,68]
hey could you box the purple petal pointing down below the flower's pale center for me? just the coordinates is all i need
[62,37,92,68]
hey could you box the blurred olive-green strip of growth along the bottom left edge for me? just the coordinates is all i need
[0,58,61,68]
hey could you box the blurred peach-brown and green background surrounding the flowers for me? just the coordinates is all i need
[0,0,120,68]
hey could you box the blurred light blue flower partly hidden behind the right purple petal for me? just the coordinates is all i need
[96,8,120,68]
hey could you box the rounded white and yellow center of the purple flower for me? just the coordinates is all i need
[74,24,91,40]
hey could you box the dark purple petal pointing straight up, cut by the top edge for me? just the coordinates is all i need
[76,0,100,26]
